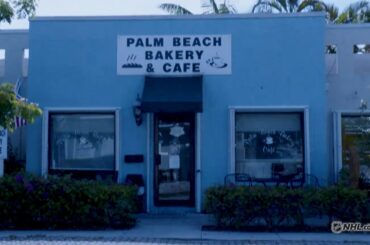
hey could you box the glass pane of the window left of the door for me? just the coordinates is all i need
[49,114,115,170]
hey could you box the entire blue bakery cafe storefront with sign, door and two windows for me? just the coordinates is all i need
[27,13,330,212]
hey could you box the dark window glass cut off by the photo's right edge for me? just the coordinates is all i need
[342,115,370,186]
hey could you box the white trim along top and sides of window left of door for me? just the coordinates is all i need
[41,107,121,179]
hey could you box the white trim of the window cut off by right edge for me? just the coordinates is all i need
[333,110,370,182]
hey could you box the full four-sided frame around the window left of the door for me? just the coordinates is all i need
[41,108,120,176]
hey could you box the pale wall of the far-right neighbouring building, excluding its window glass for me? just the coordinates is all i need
[325,24,370,180]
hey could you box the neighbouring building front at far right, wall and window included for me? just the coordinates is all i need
[325,24,370,185]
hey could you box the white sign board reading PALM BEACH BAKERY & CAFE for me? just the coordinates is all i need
[117,35,231,75]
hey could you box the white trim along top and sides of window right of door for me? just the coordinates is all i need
[229,106,311,174]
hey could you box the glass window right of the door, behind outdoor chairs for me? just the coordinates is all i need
[235,112,304,179]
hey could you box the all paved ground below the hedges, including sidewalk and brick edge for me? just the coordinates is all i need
[0,214,370,245]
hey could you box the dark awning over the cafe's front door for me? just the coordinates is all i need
[141,76,203,112]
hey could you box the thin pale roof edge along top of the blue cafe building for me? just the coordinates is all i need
[29,12,326,22]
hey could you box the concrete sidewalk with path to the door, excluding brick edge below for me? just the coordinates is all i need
[0,214,370,244]
